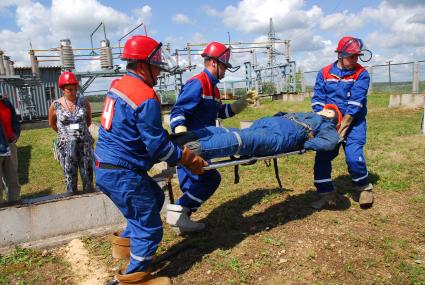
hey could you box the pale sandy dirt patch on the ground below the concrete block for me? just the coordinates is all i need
[64,239,108,285]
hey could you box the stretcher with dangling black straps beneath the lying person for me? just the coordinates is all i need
[203,149,306,189]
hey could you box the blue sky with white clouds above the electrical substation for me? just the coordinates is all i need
[0,0,425,80]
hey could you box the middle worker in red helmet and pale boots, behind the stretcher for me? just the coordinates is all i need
[167,42,257,234]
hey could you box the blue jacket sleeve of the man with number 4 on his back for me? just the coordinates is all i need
[137,99,182,164]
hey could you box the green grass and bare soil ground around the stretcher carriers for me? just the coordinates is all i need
[5,93,425,285]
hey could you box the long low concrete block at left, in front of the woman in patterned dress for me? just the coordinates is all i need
[0,192,124,247]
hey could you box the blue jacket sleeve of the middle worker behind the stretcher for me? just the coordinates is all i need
[170,79,202,132]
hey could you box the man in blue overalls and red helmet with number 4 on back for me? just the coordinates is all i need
[95,36,206,285]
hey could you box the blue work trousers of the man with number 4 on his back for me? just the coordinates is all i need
[95,167,164,274]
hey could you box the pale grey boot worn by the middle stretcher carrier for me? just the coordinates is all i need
[167,204,205,235]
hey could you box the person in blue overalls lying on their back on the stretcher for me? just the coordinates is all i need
[171,104,342,160]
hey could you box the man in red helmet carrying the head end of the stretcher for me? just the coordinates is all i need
[311,37,373,209]
